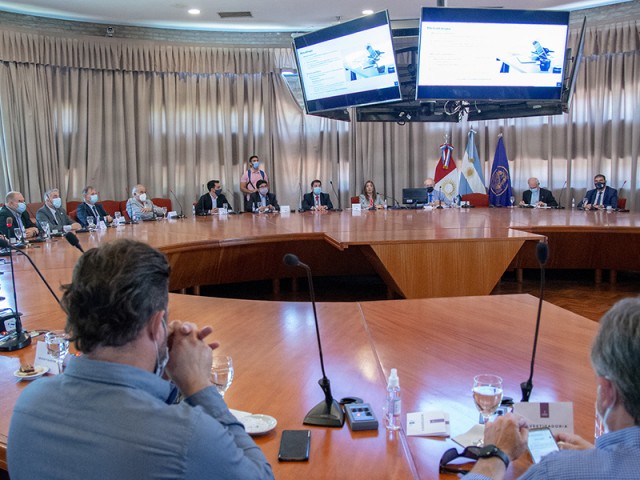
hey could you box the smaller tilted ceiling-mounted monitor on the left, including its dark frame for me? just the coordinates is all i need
[293,10,402,113]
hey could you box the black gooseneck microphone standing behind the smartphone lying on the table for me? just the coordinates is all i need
[282,253,344,427]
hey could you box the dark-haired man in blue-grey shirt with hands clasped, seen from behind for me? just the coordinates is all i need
[7,239,273,480]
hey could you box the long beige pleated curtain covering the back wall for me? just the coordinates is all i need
[0,22,640,212]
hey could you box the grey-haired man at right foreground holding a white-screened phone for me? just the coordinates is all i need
[464,297,640,480]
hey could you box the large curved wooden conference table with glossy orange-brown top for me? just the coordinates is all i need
[0,209,639,479]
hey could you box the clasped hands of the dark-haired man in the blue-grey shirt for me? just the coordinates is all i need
[166,320,219,397]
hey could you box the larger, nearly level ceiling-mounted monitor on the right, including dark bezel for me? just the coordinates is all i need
[416,7,569,101]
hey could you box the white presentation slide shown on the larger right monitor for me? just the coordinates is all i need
[418,22,567,87]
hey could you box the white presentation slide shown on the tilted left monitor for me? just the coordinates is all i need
[297,25,398,100]
